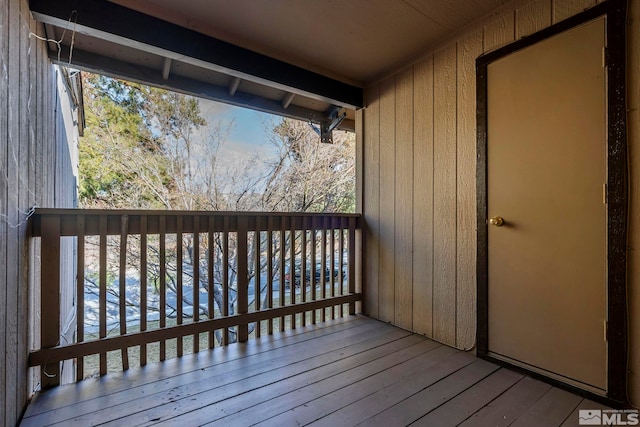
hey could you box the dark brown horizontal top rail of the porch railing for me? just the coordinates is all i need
[31,208,361,237]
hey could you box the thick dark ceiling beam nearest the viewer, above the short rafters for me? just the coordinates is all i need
[29,0,364,108]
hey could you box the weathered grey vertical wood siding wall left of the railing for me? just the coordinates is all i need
[0,0,78,426]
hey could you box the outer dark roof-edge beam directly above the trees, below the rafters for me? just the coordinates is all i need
[54,46,355,131]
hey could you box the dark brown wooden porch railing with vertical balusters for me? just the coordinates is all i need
[29,209,361,388]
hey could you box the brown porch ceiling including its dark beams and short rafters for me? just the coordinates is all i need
[30,0,505,128]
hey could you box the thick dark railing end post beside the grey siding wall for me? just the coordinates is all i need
[40,215,60,390]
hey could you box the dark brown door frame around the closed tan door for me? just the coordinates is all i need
[476,0,628,406]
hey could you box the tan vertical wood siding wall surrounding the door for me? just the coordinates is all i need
[362,0,640,398]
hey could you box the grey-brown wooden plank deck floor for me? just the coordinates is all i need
[21,316,603,427]
